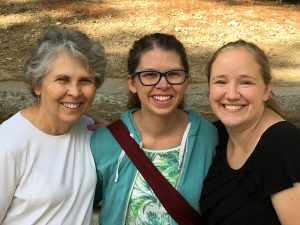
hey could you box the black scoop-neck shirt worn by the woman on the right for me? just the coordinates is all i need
[200,121,300,225]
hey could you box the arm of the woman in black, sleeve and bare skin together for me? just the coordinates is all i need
[261,122,300,225]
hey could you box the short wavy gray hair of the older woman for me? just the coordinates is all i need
[24,28,106,97]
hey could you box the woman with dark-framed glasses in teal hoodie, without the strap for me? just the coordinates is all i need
[91,33,217,225]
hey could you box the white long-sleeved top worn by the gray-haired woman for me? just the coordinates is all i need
[0,113,97,225]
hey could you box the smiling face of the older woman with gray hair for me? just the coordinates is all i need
[34,51,96,133]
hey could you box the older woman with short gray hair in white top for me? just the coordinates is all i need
[0,29,106,225]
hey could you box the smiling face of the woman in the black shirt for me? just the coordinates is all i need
[209,47,271,129]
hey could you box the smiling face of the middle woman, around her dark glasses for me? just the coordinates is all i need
[128,48,188,115]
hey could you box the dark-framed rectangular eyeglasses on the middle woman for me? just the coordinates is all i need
[133,69,188,86]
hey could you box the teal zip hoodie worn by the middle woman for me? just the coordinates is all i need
[91,109,218,225]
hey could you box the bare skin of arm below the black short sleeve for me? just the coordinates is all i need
[271,183,300,225]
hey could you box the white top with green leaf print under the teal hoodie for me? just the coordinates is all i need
[125,146,180,225]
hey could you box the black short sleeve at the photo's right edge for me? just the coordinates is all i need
[256,121,300,197]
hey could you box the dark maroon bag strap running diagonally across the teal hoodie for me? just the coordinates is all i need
[107,120,201,225]
